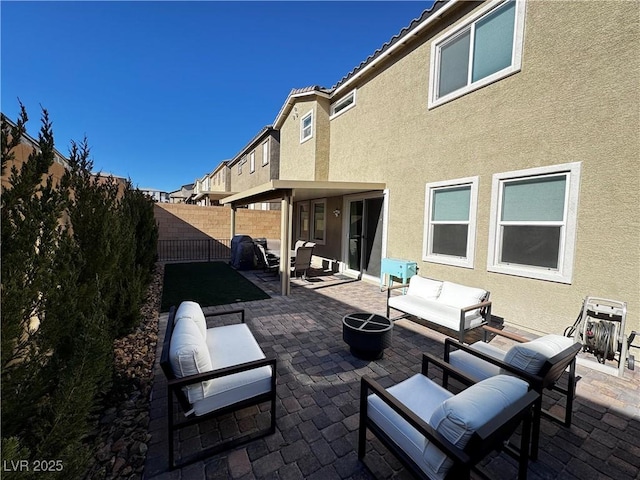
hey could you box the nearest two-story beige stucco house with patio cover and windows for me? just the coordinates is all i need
[223,0,640,333]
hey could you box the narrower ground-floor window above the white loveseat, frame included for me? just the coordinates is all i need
[423,177,478,268]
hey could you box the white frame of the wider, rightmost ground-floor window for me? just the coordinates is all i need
[487,162,581,284]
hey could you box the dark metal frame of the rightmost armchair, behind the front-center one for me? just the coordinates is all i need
[443,325,582,460]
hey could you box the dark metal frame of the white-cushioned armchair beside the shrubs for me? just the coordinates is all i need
[160,306,276,470]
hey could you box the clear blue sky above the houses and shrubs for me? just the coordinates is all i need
[0,1,432,191]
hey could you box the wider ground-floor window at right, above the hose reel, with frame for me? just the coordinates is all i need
[487,162,580,283]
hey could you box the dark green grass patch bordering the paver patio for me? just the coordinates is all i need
[160,262,270,312]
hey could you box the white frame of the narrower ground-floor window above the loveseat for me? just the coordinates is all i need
[422,176,479,268]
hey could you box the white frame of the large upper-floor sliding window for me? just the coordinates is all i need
[428,0,526,108]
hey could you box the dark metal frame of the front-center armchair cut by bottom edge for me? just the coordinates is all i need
[358,353,540,479]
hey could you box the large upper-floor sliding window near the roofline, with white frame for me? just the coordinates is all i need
[429,0,525,108]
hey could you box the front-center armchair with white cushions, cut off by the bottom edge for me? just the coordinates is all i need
[358,354,539,479]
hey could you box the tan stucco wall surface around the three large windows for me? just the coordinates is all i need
[329,2,640,333]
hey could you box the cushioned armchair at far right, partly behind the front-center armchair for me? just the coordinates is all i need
[443,326,582,460]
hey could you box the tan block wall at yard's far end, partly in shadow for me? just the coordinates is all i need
[154,203,280,240]
